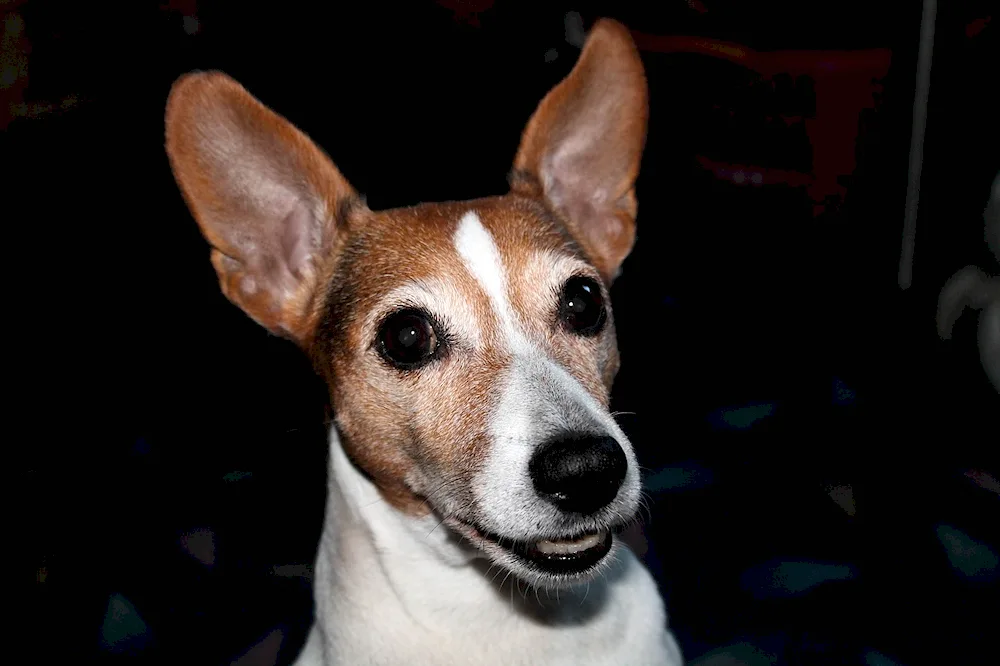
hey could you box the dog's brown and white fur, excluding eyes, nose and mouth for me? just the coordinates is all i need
[166,20,681,666]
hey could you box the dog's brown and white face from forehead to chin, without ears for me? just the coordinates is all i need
[314,196,639,579]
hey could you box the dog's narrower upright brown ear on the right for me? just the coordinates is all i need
[511,19,649,280]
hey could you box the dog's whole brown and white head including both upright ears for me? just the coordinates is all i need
[167,21,646,585]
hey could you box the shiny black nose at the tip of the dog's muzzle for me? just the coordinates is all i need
[528,435,628,514]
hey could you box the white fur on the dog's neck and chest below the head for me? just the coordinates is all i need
[296,434,682,666]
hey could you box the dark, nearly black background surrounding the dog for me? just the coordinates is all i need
[9,0,1000,666]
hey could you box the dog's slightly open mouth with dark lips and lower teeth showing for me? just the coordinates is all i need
[448,519,614,576]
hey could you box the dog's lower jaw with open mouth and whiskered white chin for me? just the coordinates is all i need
[445,518,615,588]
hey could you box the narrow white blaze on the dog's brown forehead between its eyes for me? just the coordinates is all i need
[454,210,528,348]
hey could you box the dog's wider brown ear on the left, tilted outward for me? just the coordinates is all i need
[166,72,356,344]
